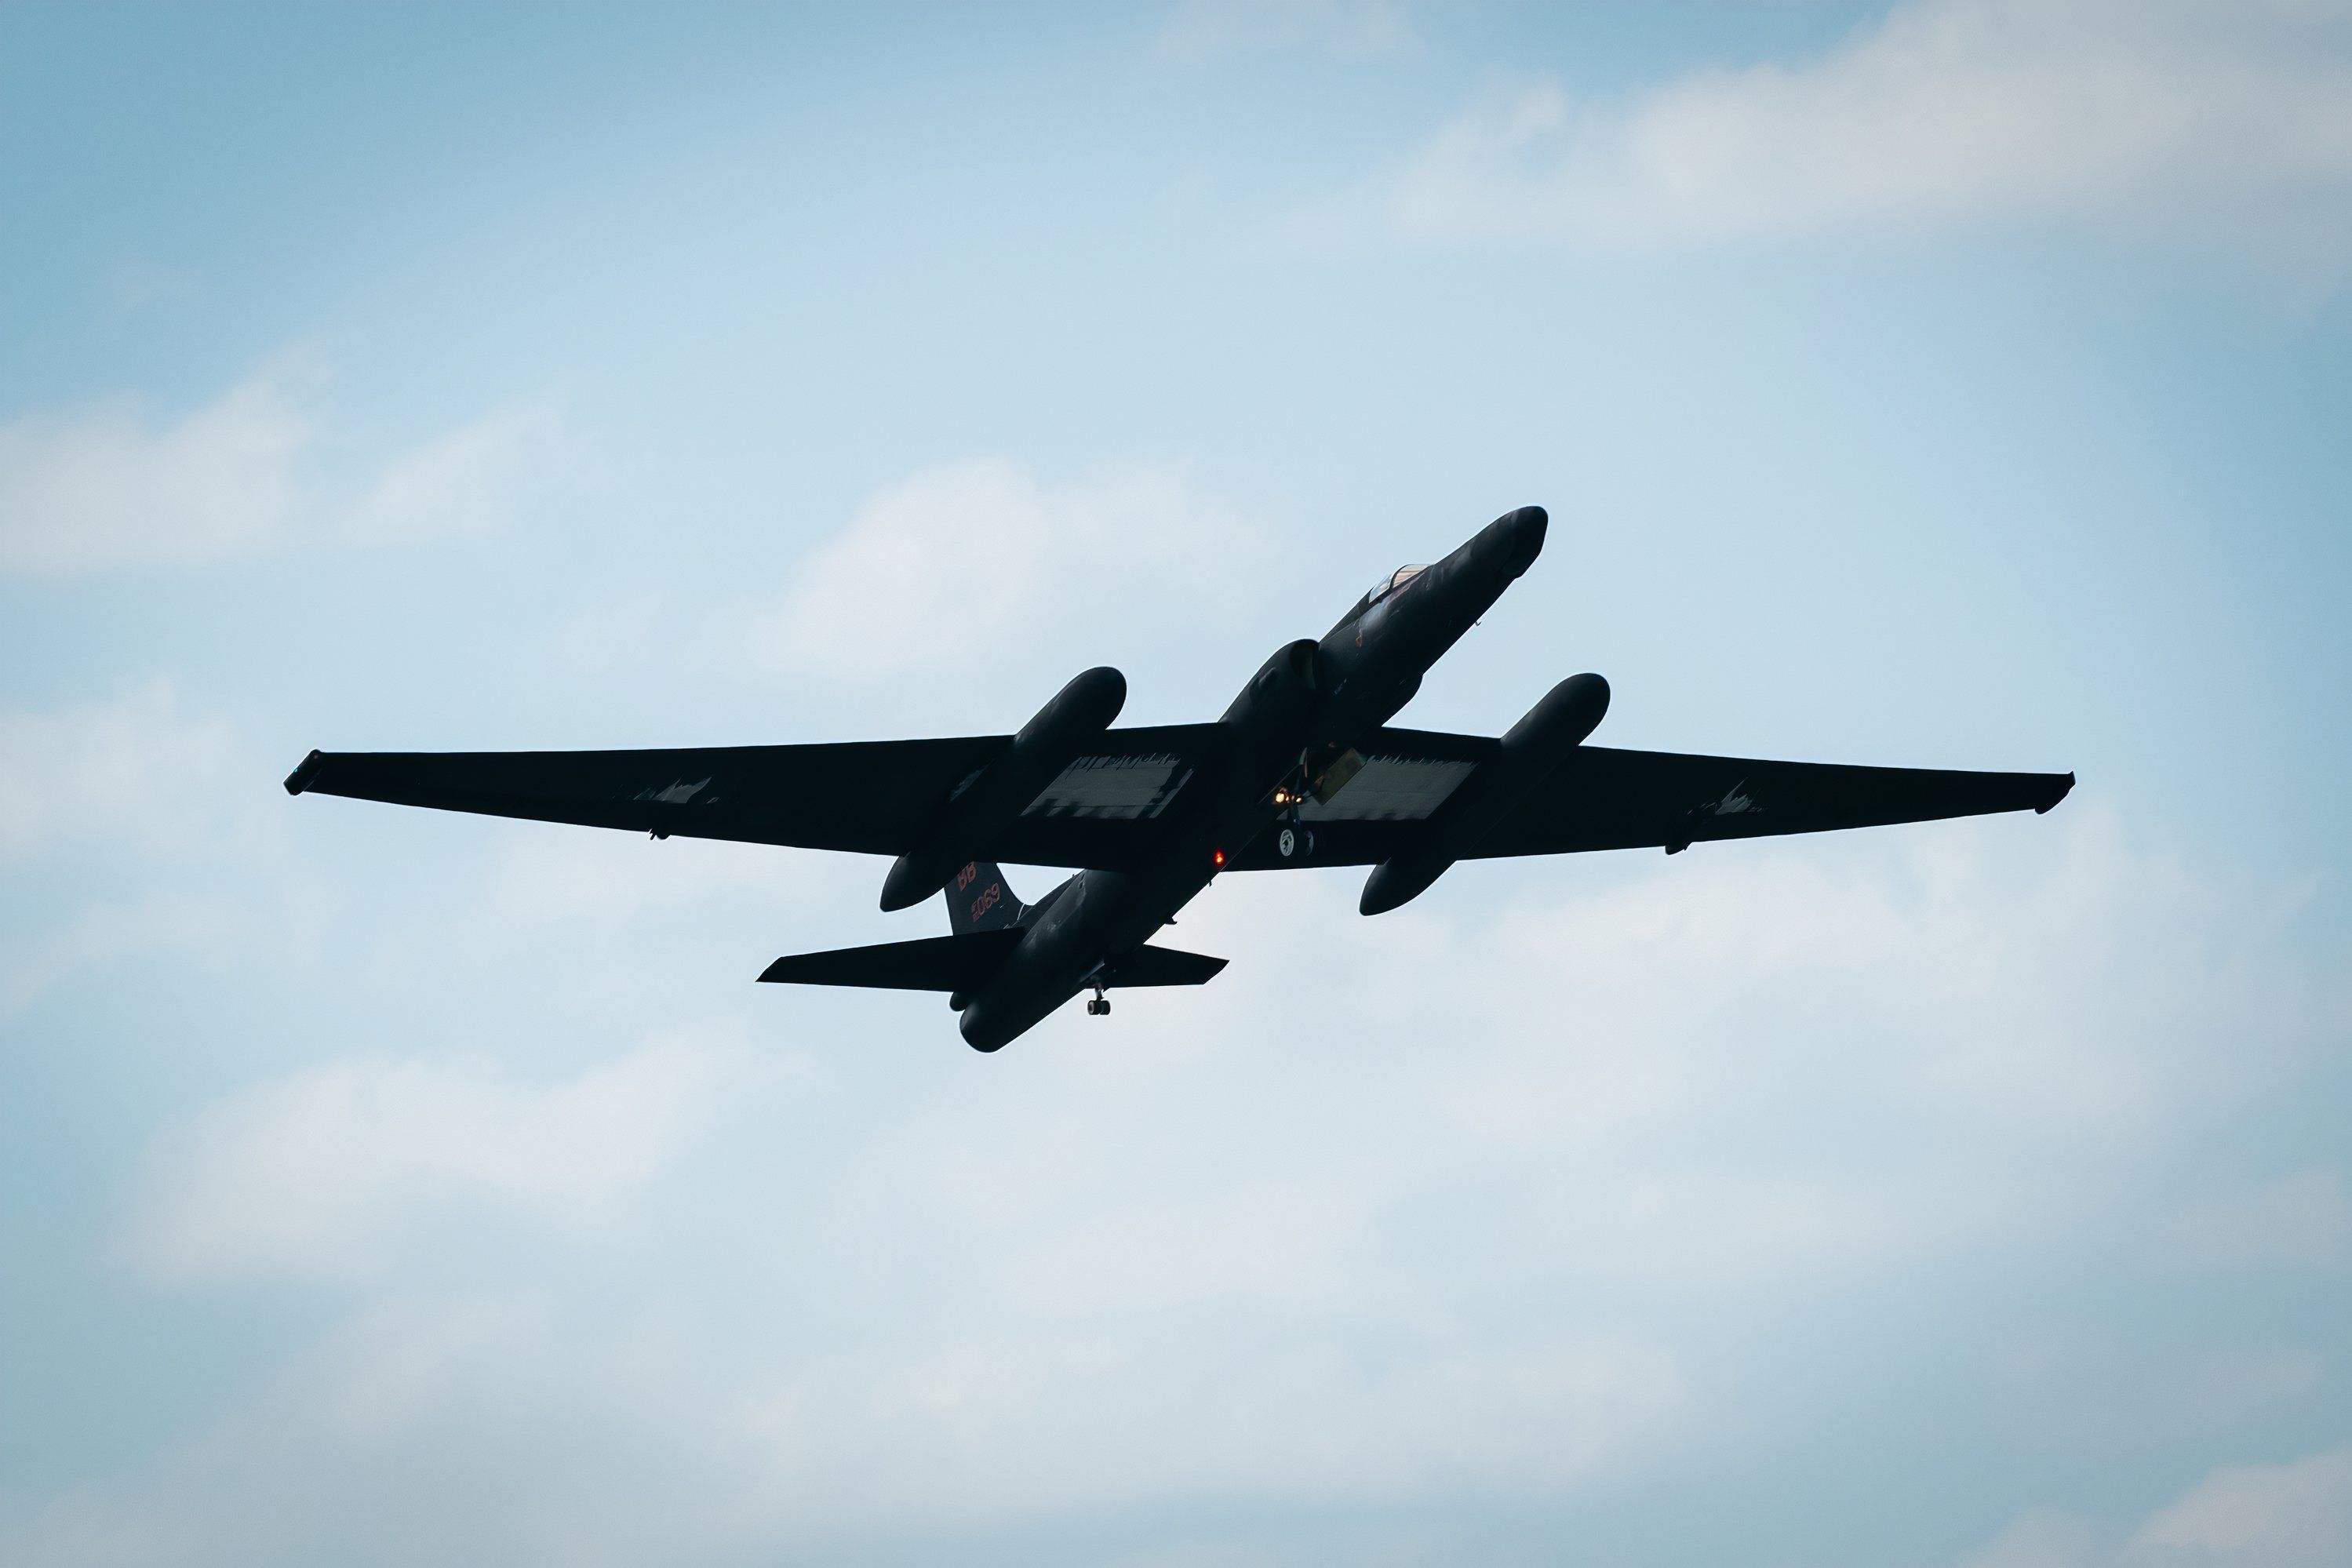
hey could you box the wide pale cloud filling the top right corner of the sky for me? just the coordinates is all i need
[1335,0,2352,268]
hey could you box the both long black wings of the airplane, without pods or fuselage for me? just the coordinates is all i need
[287,724,2074,870]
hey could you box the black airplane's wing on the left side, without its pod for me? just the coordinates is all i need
[287,724,1221,870]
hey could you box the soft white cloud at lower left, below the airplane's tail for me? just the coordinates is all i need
[132,1044,734,1279]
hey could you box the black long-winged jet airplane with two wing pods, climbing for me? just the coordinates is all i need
[285,505,2074,1051]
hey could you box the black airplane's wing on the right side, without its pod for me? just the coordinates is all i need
[1232,729,2074,870]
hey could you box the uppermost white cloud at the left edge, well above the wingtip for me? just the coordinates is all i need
[0,355,563,578]
